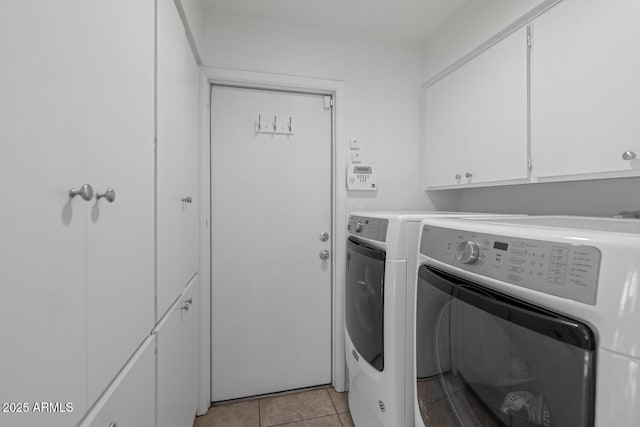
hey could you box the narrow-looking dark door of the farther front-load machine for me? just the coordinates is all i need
[346,237,386,371]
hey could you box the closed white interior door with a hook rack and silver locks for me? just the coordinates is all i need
[211,87,332,401]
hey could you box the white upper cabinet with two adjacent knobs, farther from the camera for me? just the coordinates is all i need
[425,28,529,188]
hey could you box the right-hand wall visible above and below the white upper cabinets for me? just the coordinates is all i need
[422,0,640,216]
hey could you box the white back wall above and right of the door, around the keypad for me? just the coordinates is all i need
[201,13,457,210]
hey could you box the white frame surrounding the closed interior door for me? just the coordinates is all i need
[198,67,347,415]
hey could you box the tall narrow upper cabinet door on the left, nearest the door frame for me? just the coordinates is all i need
[157,0,199,318]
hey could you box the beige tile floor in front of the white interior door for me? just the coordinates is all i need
[193,387,354,427]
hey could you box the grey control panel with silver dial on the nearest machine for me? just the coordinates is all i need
[420,225,602,305]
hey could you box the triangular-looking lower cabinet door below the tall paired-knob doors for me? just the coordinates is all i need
[79,336,156,427]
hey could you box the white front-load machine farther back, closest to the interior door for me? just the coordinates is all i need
[345,212,520,427]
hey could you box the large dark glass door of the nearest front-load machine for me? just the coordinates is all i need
[417,266,595,427]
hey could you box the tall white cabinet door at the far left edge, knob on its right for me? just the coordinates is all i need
[0,0,88,427]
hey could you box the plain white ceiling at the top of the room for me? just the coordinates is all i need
[203,0,470,44]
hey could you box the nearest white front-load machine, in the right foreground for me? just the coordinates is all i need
[415,216,640,427]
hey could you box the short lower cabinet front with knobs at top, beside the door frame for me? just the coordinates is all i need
[154,276,200,427]
